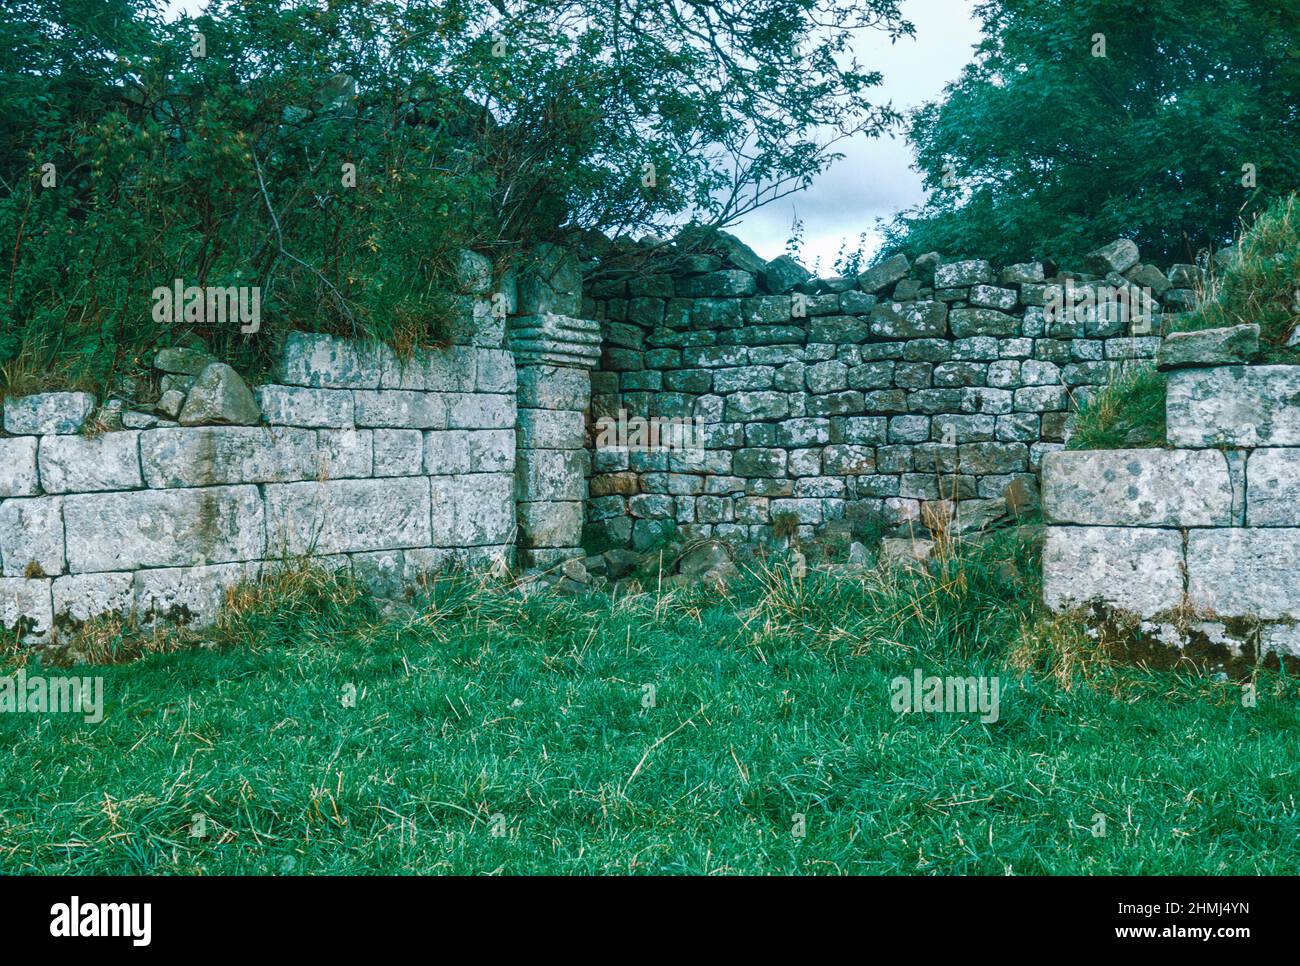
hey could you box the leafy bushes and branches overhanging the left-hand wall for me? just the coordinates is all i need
[0,0,911,389]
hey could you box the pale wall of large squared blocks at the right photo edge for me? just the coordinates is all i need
[1043,326,1300,657]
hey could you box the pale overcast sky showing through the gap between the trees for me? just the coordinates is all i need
[168,0,979,266]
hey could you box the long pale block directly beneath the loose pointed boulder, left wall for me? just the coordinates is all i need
[140,426,320,489]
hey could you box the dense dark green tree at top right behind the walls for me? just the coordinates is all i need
[885,0,1300,261]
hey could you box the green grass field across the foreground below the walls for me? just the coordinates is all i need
[0,530,1300,875]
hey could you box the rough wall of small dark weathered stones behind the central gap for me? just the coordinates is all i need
[584,234,1200,549]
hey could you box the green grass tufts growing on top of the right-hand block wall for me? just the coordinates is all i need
[1069,194,1300,450]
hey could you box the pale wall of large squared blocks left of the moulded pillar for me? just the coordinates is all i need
[0,325,516,642]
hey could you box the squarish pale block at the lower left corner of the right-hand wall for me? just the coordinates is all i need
[1043,527,1183,618]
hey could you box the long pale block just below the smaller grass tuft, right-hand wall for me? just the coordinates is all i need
[1043,450,1232,527]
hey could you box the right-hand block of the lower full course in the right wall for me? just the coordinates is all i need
[1187,528,1300,620]
